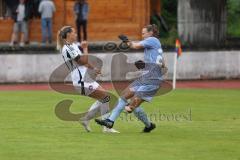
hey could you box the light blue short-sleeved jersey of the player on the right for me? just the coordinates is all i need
[140,37,163,79]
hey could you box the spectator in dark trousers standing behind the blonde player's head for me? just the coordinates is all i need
[74,0,89,42]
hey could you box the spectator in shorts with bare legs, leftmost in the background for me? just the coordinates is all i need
[10,0,30,47]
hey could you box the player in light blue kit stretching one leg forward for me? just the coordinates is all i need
[95,25,166,132]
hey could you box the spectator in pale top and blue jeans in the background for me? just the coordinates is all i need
[38,0,56,44]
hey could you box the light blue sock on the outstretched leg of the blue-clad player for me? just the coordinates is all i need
[108,98,127,122]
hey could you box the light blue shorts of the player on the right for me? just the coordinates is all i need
[129,78,162,102]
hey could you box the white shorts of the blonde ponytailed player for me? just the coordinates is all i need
[73,81,100,96]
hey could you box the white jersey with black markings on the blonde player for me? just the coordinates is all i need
[62,43,87,84]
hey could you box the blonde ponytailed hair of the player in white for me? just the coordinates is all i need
[57,26,73,50]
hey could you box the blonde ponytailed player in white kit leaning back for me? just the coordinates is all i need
[57,26,119,133]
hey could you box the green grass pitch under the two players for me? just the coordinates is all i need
[0,89,240,160]
